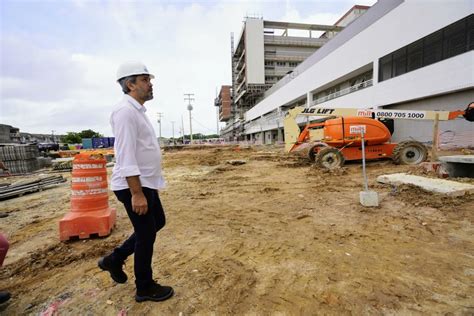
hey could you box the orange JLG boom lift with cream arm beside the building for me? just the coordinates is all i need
[284,102,474,169]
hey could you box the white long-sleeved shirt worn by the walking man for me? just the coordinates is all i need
[110,94,166,191]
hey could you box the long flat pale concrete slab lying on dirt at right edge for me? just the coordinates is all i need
[377,173,474,196]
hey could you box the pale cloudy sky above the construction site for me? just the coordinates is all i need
[0,0,376,137]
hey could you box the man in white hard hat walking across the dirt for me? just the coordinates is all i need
[99,62,174,302]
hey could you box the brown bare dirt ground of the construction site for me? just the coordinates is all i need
[0,147,474,315]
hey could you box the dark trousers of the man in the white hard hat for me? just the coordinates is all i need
[111,188,166,289]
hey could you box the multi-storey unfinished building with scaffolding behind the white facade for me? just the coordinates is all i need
[215,6,369,139]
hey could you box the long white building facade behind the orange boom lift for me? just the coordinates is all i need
[245,0,474,146]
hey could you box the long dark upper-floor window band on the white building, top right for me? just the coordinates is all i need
[379,14,474,82]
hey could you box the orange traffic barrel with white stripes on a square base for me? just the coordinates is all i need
[59,154,116,241]
